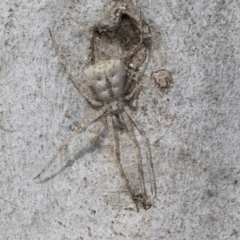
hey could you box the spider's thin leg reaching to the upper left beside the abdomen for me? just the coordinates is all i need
[48,29,103,107]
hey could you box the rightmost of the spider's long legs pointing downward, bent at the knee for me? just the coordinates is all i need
[125,106,156,194]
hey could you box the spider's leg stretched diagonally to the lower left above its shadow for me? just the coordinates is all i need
[34,109,106,179]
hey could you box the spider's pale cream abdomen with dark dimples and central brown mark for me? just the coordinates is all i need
[84,59,126,102]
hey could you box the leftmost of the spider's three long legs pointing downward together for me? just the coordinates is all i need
[107,115,139,211]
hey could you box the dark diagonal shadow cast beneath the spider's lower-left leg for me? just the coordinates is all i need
[37,126,108,184]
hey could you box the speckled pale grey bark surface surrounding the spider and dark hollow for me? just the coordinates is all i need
[0,0,240,240]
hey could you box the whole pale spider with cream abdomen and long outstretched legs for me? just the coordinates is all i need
[35,3,154,211]
